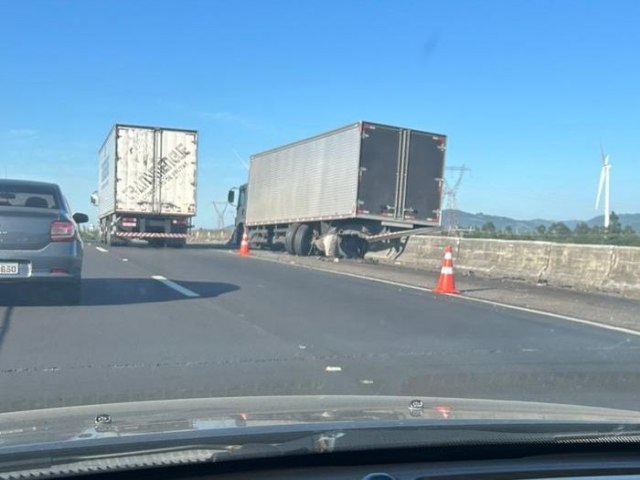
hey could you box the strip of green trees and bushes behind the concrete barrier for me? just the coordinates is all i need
[456,212,640,247]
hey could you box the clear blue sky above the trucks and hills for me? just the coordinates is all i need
[0,0,640,226]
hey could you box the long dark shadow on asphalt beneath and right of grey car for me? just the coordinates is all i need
[0,278,240,308]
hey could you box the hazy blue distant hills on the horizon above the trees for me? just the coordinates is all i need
[442,210,640,233]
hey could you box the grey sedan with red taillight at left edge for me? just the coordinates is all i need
[0,179,88,304]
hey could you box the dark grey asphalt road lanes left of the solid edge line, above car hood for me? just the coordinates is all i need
[0,245,640,411]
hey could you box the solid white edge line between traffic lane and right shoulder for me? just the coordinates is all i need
[242,256,640,337]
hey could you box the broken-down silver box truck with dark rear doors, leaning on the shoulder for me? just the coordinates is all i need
[229,121,447,257]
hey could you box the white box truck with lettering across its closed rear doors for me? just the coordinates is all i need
[91,124,198,247]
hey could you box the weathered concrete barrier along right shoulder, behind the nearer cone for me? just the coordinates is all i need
[367,236,640,297]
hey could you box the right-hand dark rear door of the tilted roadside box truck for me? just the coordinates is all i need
[402,131,446,222]
